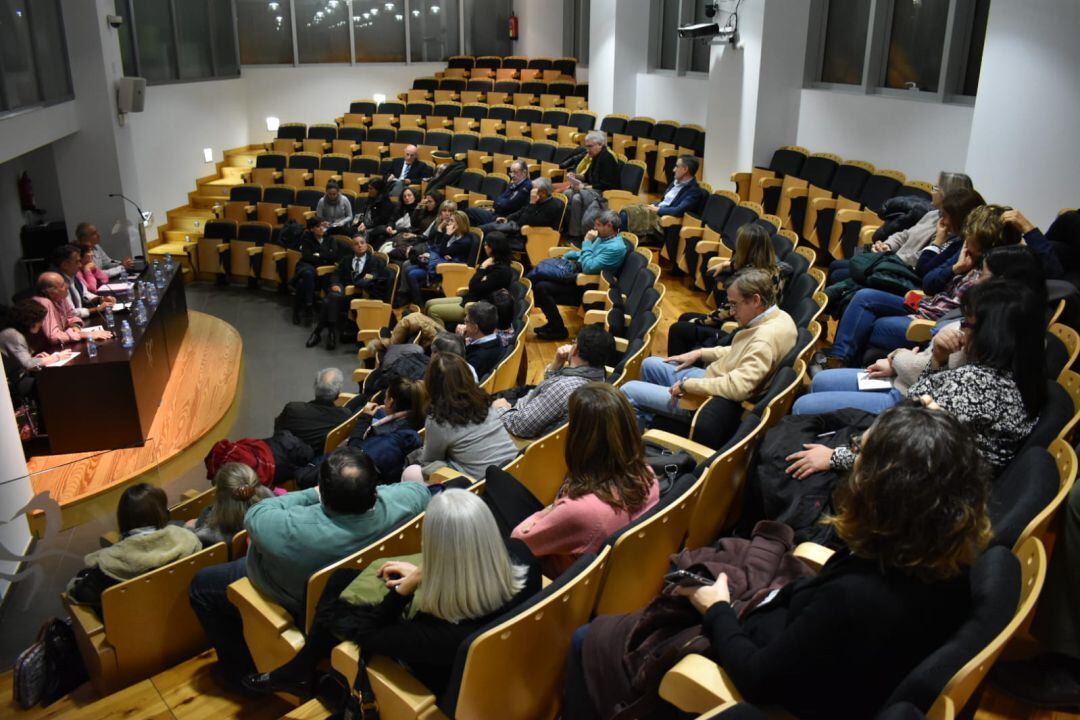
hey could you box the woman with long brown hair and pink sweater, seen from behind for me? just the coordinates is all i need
[484,382,660,578]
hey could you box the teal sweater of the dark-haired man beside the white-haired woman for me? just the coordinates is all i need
[244,483,431,617]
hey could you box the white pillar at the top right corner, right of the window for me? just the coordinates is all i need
[967,0,1080,229]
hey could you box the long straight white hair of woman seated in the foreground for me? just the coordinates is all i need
[415,490,528,623]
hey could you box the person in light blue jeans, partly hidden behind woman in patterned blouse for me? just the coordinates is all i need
[792,245,1047,415]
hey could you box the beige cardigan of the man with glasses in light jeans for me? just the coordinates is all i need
[683,308,798,402]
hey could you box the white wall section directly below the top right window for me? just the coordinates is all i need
[799,89,985,183]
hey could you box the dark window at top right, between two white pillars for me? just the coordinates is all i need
[807,0,990,103]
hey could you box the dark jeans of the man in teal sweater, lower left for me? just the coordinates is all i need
[188,557,255,683]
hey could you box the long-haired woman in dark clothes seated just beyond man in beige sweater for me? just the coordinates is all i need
[667,223,792,355]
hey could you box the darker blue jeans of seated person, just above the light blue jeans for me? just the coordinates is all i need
[829,288,915,363]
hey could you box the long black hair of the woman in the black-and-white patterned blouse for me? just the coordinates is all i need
[961,279,1047,417]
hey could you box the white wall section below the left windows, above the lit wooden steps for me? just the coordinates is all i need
[127,79,247,237]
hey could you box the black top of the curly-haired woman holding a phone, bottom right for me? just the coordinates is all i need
[702,551,971,718]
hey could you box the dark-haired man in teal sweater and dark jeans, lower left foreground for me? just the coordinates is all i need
[188,447,431,687]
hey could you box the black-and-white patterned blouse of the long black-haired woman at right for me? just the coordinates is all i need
[831,365,1038,474]
